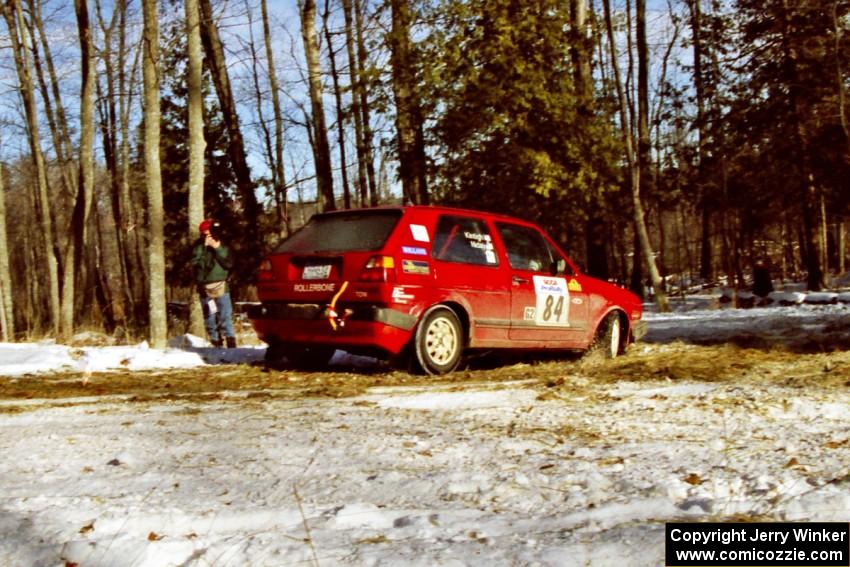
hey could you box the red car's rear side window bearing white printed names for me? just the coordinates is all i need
[431,215,499,266]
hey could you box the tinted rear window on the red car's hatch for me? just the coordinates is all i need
[275,210,401,254]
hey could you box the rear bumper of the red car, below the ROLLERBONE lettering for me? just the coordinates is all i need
[248,303,417,354]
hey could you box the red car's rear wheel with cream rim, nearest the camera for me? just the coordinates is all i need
[413,306,464,375]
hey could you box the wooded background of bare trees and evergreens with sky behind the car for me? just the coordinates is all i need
[0,0,850,347]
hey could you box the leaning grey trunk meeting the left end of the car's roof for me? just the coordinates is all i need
[301,0,336,211]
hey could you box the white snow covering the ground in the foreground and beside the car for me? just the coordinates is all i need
[0,304,850,566]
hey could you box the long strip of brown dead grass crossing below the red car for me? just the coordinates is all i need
[0,344,850,413]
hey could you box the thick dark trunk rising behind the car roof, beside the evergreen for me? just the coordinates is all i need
[389,0,429,205]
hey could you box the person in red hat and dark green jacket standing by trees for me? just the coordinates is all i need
[192,219,236,348]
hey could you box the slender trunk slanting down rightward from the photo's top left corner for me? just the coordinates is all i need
[2,0,60,335]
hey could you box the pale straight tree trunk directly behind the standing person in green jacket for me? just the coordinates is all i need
[185,0,207,337]
